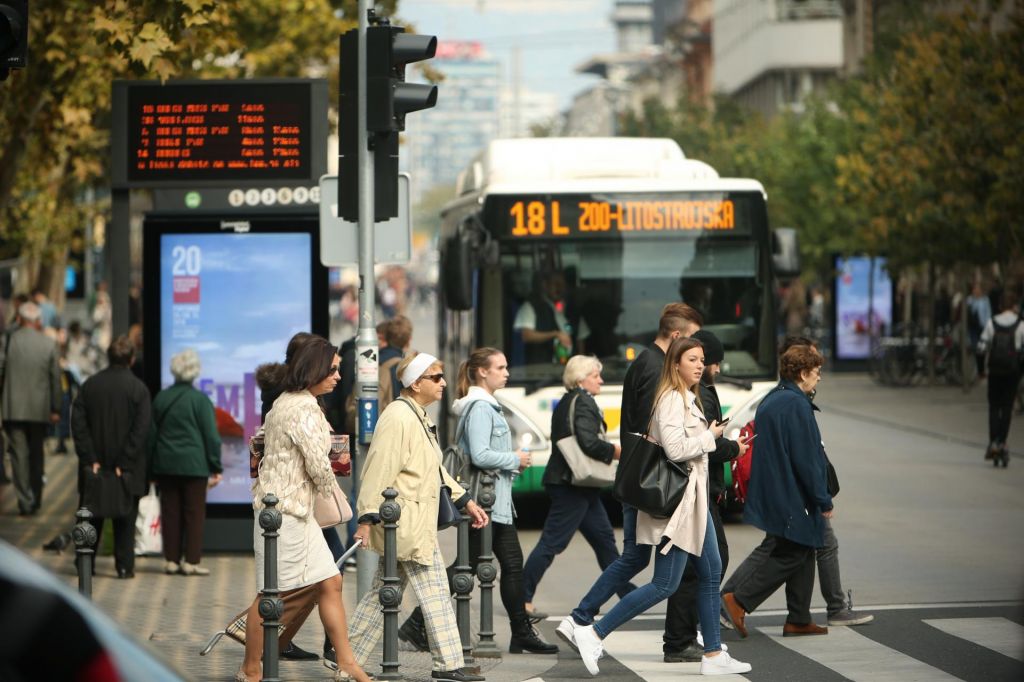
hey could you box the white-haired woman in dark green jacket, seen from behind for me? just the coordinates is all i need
[148,348,223,576]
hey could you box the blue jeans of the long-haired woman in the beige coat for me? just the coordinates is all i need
[594,512,722,652]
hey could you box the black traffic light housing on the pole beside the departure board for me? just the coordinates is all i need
[338,22,437,222]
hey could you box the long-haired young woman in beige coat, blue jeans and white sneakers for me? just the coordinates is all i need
[573,338,751,675]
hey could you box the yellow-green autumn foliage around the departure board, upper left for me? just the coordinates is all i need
[0,0,397,284]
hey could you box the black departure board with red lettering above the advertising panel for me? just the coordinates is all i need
[113,80,327,186]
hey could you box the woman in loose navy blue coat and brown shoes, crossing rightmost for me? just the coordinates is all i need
[722,346,833,637]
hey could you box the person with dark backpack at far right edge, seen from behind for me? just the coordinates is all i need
[979,286,1024,467]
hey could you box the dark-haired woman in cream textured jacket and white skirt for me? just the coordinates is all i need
[236,337,370,682]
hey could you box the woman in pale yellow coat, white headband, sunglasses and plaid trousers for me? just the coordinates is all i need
[349,353,487,682]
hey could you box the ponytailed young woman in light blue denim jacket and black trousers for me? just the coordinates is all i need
[398,347,558,653]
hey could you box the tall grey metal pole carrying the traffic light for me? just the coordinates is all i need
[352,0,379,599]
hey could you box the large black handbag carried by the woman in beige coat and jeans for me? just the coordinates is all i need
[611,433,690,518]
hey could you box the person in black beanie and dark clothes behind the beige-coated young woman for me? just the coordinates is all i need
[663,330,748,663]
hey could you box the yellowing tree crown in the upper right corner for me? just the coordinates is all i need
[838,9,1024,269]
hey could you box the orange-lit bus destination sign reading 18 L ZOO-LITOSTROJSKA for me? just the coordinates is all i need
[486,193,764,240]
